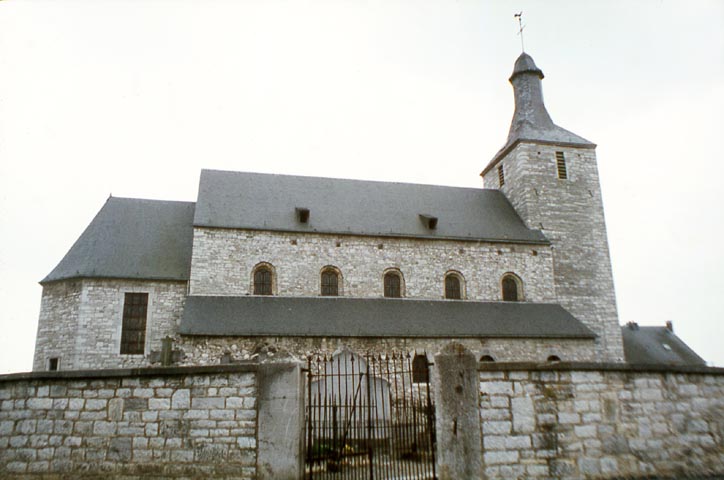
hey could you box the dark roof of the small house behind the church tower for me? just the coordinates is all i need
[621,323,706,366]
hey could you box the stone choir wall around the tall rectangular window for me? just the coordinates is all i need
[33,279,187,371]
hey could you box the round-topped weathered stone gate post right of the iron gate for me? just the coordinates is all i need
[433,342,482,480]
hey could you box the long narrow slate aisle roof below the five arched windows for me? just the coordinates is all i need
[179,296,595,339]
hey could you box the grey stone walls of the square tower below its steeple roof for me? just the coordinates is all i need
[484,143,624,362]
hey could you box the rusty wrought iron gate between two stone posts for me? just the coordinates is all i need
[304,350,437,480]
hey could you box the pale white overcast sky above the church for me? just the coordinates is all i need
[0,0,724,373]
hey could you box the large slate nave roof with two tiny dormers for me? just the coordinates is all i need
[194,170,548,244]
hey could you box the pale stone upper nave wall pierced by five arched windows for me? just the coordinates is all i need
[190,228,556,302]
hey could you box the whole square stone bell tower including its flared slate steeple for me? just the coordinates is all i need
[481,53,624,362]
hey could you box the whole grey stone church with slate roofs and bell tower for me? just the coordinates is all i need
[33,53,702,371]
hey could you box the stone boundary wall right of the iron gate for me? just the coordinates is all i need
[479,365,724,479]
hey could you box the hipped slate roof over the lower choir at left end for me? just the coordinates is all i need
[40,197,194,283]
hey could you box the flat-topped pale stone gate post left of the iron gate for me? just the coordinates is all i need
[256,362,304,480]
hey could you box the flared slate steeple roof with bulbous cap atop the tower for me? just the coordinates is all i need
[483,52,596,174]
